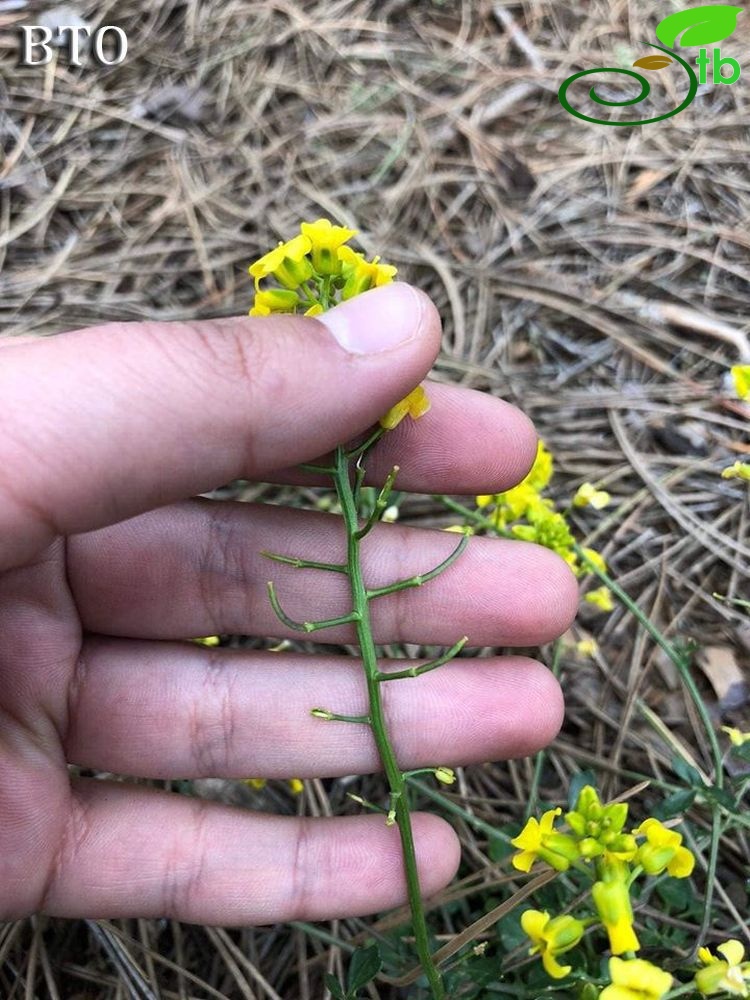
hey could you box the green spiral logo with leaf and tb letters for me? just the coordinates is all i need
[557,4,743,126]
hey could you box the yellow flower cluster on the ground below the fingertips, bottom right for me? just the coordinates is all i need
[511,785,695,1000]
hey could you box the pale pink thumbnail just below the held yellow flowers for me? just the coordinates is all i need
[316,281,423,354]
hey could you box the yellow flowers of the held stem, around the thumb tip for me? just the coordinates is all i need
[248,219,430,430]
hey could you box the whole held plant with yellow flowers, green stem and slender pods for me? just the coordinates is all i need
[249,219,468,1000]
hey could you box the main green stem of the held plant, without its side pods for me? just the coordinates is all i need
[333,447,445,1000]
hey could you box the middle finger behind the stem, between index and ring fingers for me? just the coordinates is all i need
[69,500,577,646]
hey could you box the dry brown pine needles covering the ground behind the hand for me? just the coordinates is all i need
[0,0,750,1000]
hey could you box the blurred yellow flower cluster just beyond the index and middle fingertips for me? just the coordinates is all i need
[476,441,614,611]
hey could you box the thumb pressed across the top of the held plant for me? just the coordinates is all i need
[0,283,440,566]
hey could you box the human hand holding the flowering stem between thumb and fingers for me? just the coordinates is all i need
[0,284,576,924]
